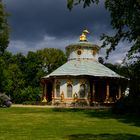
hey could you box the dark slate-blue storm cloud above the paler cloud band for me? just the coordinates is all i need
[5,0,110,41]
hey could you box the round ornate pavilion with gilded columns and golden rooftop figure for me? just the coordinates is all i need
[41,30,126,105]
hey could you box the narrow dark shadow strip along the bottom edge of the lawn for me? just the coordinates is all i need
[67,134,140,140]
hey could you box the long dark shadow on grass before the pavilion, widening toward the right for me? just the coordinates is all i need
[53,108,140,127]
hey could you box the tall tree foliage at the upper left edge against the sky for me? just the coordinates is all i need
[0,1,9,55]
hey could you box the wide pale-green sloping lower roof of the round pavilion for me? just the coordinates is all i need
[43,59,124,78]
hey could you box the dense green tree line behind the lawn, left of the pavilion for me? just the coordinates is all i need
[0,48,66,103]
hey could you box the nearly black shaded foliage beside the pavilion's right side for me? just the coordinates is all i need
[109,60,140,115]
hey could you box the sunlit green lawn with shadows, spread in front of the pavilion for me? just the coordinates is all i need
[0,107,140,140]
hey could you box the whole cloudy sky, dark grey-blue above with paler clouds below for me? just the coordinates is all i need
[4,0,128,63]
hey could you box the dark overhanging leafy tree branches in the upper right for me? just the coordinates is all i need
[67,0,140,58]
